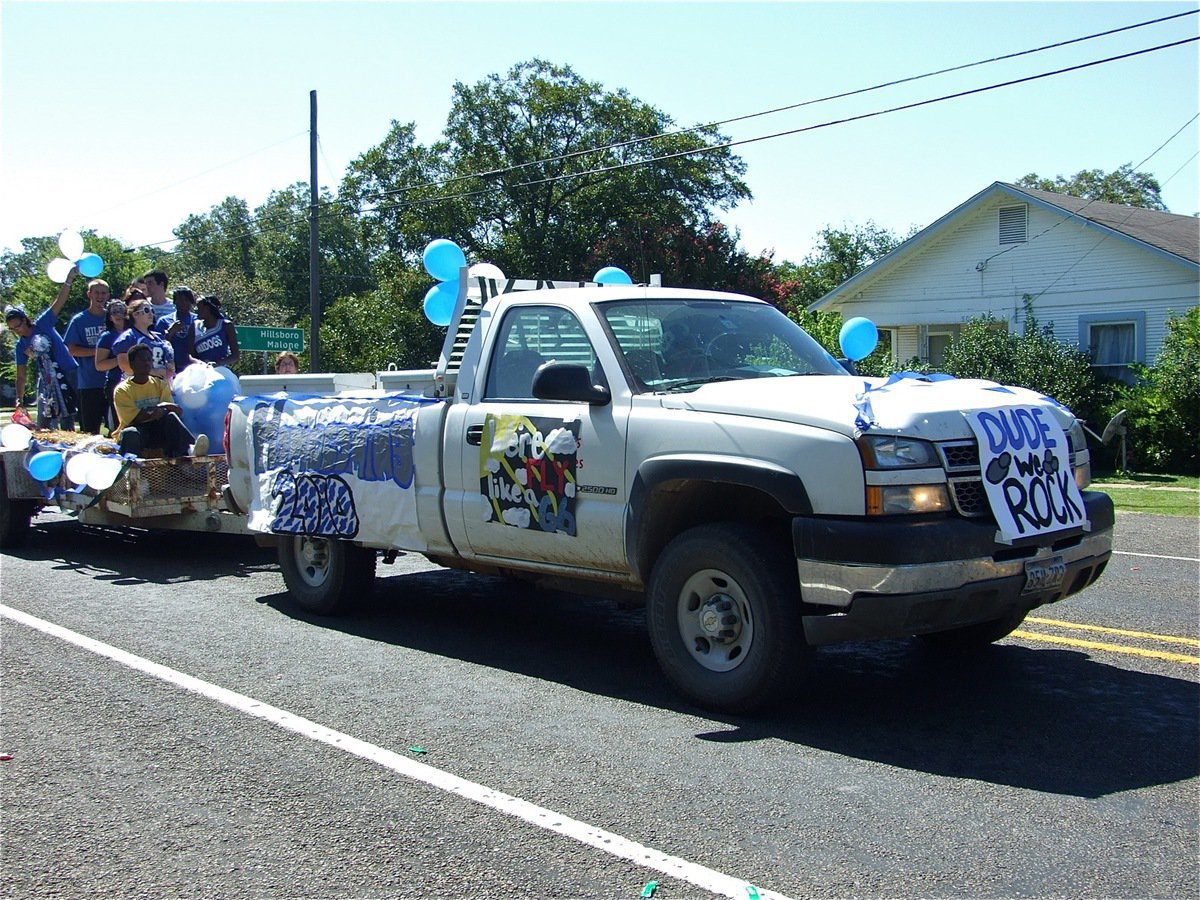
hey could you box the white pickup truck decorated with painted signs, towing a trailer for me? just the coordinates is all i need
[227,278,1114,712]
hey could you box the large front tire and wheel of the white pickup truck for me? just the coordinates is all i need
[647,523,806,713]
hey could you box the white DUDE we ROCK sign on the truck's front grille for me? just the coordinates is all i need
[966,407,1087,541]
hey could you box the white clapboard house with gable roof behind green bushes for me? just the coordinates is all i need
[810,181,1200,376]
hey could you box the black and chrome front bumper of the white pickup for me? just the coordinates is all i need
[792,491,1114,644]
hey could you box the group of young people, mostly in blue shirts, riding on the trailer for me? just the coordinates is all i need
[4,268,239,458]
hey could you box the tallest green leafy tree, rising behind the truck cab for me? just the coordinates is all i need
[342,59,750,277]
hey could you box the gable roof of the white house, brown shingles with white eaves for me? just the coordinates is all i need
[809,181,1200,310]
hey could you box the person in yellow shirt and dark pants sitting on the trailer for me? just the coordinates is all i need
[113,343,209,460]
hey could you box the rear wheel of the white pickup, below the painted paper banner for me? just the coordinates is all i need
[278,534,376,616]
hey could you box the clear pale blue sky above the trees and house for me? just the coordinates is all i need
[0,0,1200,276]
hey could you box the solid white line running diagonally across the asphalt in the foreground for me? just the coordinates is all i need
[0,604,787,900]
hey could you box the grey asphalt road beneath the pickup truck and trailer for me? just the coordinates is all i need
[0,516,1200,898]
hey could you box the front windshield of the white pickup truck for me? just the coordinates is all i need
[599,298,846,391]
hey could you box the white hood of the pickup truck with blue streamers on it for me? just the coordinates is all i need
[662,373,1073,440]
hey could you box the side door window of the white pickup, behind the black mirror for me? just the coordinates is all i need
[484,306,598,400]
